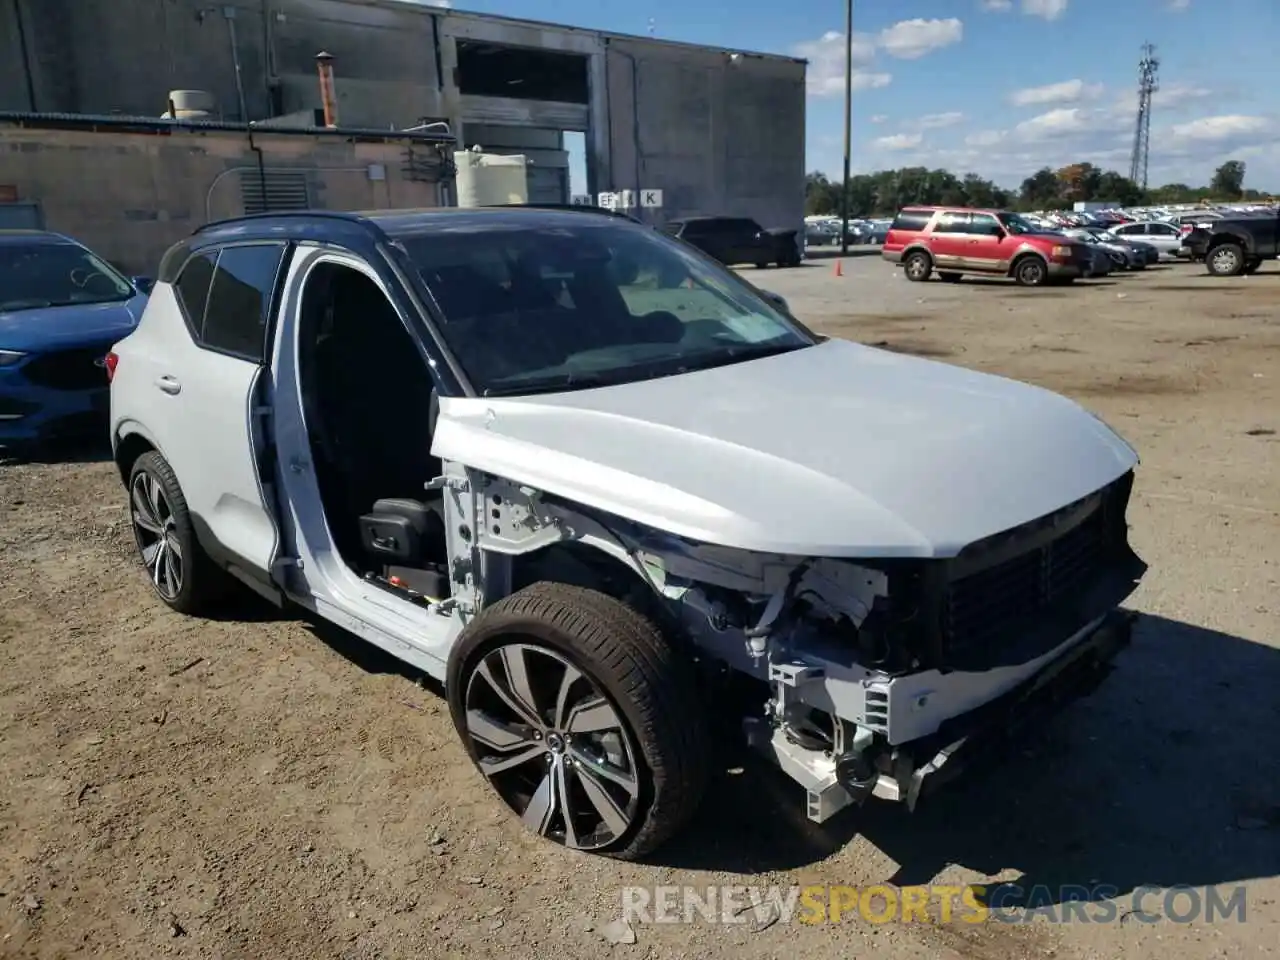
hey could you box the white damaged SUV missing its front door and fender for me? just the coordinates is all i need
[108,207,1146,858]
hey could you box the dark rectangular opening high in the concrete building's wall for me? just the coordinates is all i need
[458,40,590,104]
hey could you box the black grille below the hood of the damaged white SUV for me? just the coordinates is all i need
[942,497,1108,654]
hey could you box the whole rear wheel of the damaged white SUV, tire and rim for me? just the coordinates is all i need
[129,451,225,613]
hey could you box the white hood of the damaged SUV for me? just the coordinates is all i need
[433,339,1137,557]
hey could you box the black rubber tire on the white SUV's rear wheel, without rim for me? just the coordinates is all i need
[129,451,230,616]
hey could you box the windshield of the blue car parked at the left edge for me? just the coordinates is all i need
[0,243,134,310]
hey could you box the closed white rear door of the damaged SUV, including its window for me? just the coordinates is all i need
[152,243,287,600]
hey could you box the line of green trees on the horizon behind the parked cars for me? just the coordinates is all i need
[805,160,1263,216]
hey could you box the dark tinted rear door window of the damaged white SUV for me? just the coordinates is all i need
[200,243,284,362]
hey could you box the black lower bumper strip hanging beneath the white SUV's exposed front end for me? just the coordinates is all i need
[876,609,1137,808]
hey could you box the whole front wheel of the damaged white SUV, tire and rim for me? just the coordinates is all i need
[445,582,709,859]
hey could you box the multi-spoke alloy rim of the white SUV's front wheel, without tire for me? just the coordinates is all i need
[465,643,640,850]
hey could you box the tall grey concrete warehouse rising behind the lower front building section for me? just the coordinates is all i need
[0,0,805,227]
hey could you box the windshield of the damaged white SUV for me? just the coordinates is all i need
[399,218,814,396]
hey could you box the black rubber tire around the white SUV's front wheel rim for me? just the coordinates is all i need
[445,582,710,860]
